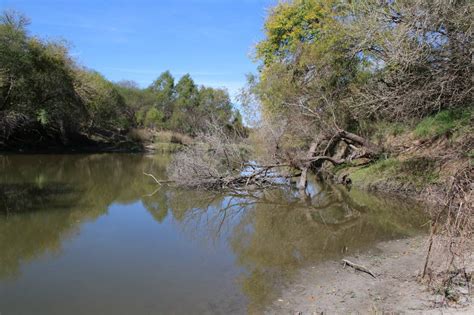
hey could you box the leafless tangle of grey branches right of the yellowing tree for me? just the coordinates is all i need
[348,0,473,121]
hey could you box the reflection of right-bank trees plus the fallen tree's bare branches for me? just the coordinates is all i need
[160,181,430,313]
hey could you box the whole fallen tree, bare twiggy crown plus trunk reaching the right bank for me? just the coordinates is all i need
[168,126,380,191]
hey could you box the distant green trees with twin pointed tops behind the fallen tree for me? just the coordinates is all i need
[118,71,243,136]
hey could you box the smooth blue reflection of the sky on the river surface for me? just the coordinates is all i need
[0,202,245,314]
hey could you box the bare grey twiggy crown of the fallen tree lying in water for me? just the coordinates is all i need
[168,126,297,190]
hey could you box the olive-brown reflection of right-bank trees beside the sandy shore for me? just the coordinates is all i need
[231,187,423,312]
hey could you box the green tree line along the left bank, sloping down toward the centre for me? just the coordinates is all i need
[0,11,243,148]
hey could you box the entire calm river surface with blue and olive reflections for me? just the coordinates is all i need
[0,154,425,315]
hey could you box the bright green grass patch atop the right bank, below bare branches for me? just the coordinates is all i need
[414,109,474,138]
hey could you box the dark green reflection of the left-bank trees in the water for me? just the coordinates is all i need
[0,154,167,278]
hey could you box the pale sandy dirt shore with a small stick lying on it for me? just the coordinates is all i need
[266,237,474,314]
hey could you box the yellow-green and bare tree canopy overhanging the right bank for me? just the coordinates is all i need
[246,0,472,150]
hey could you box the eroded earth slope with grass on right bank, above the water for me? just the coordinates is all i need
[335,109,474,207]
